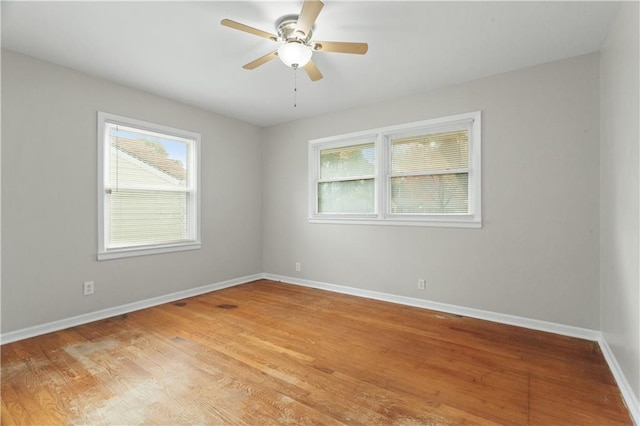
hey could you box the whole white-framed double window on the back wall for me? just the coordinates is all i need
[309,112,482,228]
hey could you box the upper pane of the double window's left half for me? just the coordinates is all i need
[320,143,376,179]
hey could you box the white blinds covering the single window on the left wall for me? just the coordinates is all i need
[105,124,195,249]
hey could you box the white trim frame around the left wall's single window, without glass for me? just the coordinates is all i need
[97,111,202,260]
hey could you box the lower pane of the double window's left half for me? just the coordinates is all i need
[318,179,375,213]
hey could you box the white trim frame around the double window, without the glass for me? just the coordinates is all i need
[308,111,482,228]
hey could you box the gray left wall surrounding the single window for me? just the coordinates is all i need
[2,51,262,333]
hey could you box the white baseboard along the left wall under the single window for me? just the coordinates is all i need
[0,274,264,344]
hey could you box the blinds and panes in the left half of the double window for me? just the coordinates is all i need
[317,142,375,214]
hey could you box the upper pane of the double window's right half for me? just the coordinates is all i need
[391,130,469,174]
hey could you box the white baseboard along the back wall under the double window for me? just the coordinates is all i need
[264,274,601,341]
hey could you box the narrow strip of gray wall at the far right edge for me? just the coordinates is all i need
[600,2,640,399]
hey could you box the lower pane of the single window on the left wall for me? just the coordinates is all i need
[109,189,190,247]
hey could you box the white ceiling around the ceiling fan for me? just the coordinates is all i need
[2,0,619,126]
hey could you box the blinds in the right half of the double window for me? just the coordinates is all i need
[390,129,469,214]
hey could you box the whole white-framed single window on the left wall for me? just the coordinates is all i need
[98,112,201,260]
